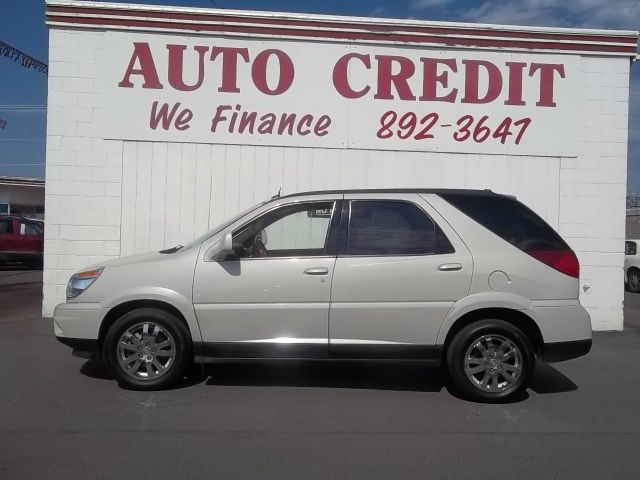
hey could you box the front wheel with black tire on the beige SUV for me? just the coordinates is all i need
[102,308,193,390]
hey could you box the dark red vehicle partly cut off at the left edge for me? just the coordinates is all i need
[0,215,44,267]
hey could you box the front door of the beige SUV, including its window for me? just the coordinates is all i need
[193,197,340,357]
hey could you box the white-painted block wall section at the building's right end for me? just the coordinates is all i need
[559,57,630,330]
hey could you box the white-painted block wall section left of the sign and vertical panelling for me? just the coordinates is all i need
[42,28,122,316]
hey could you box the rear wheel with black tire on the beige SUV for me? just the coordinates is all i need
[446,319,536,403]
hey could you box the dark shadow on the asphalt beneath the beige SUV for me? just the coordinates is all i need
[80,359,578,403]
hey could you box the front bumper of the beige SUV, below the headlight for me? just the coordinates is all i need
[53,303,104,358]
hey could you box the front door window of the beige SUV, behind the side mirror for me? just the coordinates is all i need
[233,202,334,258]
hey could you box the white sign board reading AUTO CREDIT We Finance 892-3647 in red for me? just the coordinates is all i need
[104,32,580,157]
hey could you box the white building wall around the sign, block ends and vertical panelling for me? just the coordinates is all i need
[43,28,629,330]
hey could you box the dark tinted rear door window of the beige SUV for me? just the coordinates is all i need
[347,200,453,255]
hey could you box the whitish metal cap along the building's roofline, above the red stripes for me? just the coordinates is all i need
[46,0,640,38]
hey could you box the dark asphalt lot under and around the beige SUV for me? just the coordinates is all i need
[0,272,640,480]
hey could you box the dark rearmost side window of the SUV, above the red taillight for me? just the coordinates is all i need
[440,193,569,251]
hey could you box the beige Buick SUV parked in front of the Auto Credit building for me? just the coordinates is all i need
[54,190,591,402]
